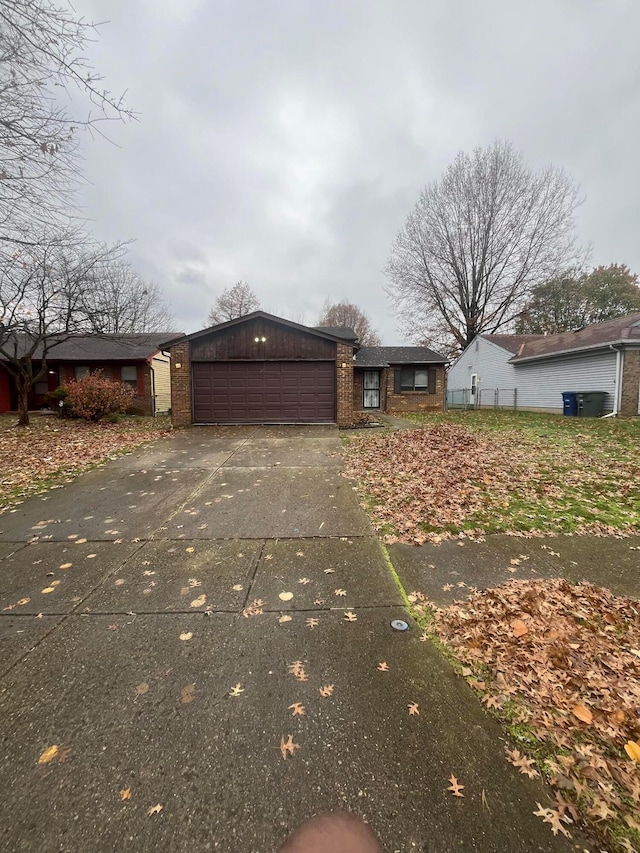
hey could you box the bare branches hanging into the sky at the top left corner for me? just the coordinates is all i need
[0,0,133,248]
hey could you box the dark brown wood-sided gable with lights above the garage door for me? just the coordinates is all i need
[191,318,336,361]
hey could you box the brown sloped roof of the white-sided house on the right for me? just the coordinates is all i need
[509,314,640,364]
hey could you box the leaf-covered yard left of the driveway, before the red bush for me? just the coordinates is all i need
[0,415,168,509]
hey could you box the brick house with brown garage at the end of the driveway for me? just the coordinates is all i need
[164,311,444,426]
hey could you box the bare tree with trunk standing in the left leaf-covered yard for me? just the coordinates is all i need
[0,233,129,426]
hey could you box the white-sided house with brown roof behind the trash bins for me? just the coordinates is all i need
[447,314,640,415]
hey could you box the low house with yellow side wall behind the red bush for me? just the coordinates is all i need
[0,332,171,415]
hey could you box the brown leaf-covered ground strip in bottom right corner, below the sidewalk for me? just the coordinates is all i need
[434,579,640,849]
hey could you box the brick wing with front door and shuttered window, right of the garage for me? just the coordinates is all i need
[353,347,446,413]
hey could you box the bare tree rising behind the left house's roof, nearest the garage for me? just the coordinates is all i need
[86,262,173,334]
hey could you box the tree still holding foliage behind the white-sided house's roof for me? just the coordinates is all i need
[515,264,640,335]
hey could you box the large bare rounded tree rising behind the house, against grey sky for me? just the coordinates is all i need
[386,142,580,348]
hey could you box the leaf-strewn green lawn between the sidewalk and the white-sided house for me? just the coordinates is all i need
[345,411,640,542]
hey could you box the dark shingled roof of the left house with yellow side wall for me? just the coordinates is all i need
[0,332,180,361]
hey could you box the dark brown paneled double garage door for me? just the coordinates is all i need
[193,361,336,424]
